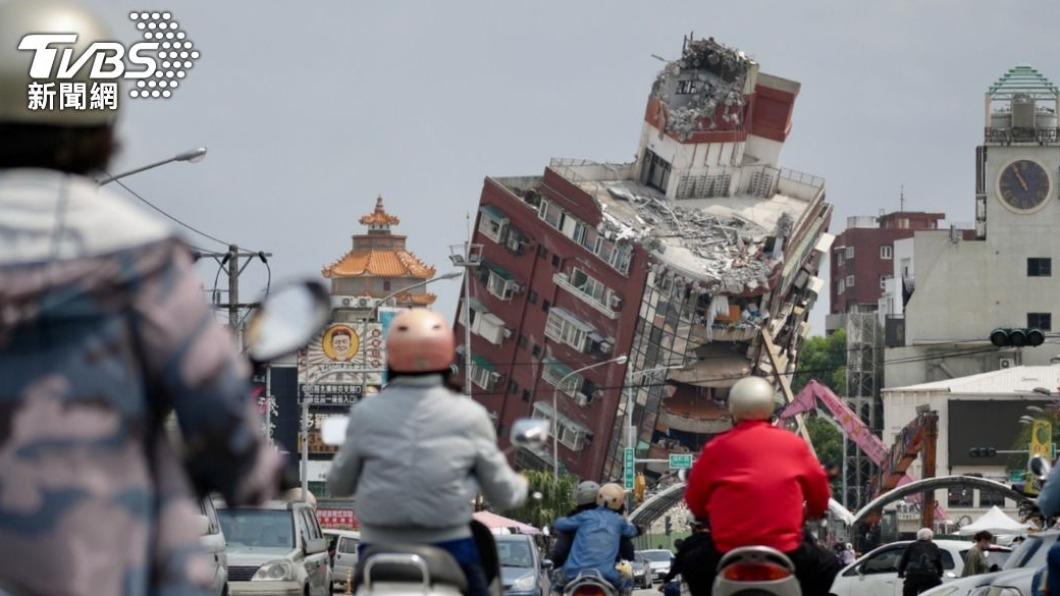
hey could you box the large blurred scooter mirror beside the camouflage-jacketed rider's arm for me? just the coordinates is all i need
[244,280,331,362]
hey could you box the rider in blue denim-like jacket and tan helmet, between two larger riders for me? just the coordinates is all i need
[553,484,637,589]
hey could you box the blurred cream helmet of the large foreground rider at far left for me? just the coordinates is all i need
[0,0,121,126]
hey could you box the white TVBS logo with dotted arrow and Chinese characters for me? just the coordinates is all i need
[18,11,199,110]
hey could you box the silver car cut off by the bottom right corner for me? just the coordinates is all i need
[923,530,1060,596]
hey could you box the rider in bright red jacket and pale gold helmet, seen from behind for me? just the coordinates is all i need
[685,376,840,596]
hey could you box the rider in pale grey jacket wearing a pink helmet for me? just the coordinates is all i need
[328,309,528,594]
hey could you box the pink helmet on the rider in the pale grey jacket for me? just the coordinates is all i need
[387,309,456,373]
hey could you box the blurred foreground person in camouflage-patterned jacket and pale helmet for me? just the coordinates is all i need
[0,0,281,596]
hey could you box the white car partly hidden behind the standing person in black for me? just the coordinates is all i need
[831,540,1011,596]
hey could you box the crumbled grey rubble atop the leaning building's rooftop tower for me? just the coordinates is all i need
[653,37,752,139]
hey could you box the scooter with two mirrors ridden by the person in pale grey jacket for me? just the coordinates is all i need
[321,416,549,596]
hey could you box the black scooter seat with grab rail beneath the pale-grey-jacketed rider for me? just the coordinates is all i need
[356,544,467,593]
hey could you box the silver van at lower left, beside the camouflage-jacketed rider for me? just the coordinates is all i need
[217,501,332,596]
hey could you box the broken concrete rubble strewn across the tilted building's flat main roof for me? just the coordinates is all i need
[604,185,780,295]
